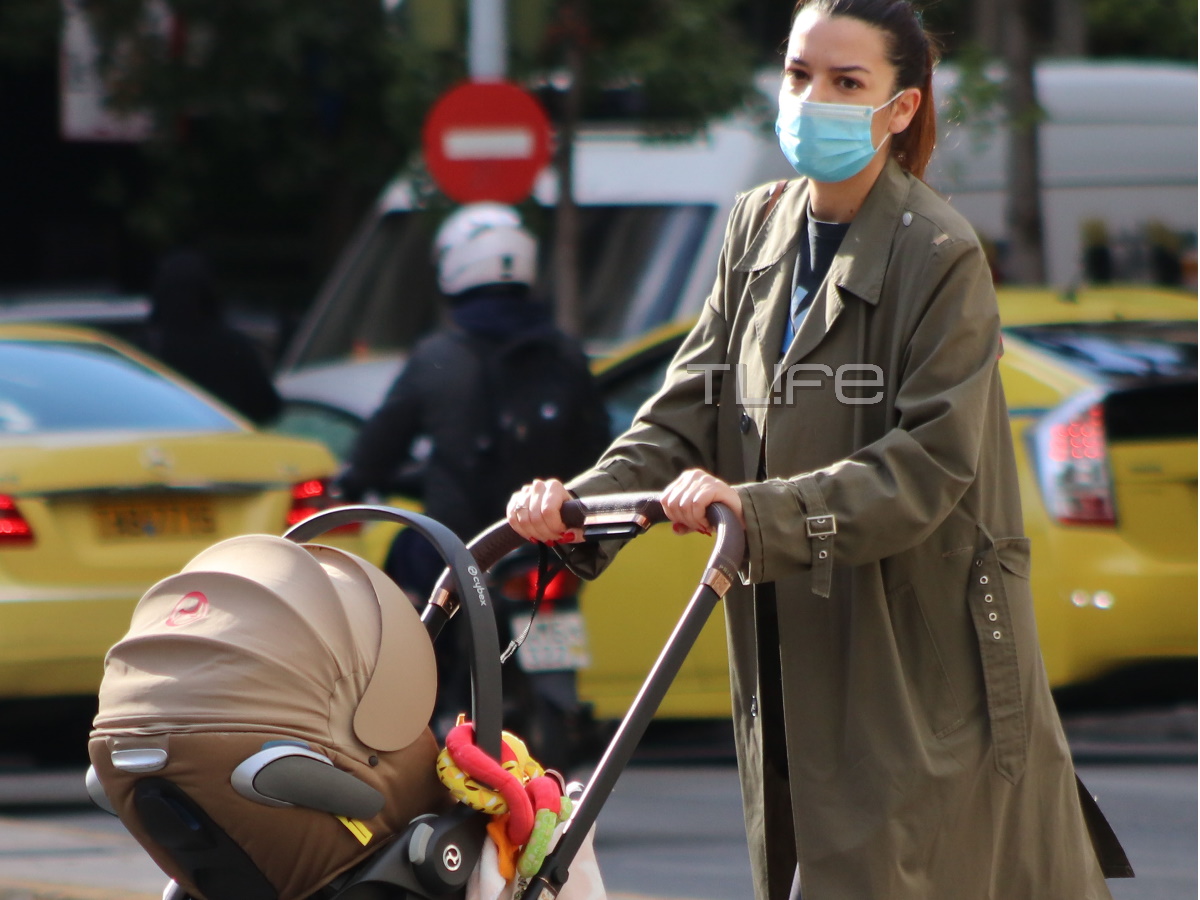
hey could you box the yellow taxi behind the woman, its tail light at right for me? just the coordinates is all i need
[580,287,1198,719]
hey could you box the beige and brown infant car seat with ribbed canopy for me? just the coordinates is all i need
[89,534,451,900]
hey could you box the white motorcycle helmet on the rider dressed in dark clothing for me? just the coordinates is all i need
[433,203,538,296]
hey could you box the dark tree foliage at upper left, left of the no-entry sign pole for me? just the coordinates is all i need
[79,0,454,252]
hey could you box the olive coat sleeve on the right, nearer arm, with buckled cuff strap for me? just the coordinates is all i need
[737,240,1000,583]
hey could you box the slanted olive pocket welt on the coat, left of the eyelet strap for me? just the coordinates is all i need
[887,584,965,738]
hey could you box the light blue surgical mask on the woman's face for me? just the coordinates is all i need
[775,91,904,181]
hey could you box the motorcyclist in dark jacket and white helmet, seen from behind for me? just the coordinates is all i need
[337,203,610,748]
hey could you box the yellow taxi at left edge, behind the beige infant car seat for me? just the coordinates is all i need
[0,324,360,700]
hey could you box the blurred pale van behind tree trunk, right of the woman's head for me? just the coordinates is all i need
[926,60,1196,287]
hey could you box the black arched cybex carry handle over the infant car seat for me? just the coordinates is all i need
[283,505,504,760]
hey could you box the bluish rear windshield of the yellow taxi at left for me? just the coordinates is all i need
[0,341,241,436]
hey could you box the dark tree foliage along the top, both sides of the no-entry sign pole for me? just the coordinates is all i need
[77,0,755,255]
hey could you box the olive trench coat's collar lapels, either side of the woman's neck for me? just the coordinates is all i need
[733,157,911,305]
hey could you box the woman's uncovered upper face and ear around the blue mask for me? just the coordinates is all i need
[779,8,920,146]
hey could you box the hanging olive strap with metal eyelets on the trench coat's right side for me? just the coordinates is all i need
[967,527,1030,784]
